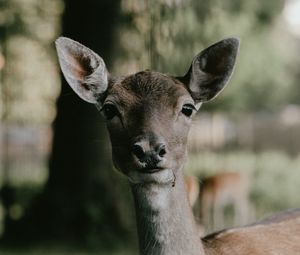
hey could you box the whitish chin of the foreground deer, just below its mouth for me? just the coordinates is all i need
[128,169,175,184]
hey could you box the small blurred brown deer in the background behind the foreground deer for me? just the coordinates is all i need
[186,172,252,233]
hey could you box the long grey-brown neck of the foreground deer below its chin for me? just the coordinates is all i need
[132,171,204,255]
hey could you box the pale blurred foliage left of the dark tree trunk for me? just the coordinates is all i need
[0,0,63,124]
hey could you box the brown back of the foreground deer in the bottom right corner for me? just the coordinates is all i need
[203,210,300,255]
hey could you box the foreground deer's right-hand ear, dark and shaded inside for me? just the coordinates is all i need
[178,38,239,103]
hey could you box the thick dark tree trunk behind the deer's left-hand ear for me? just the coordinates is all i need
[1,0,135,247]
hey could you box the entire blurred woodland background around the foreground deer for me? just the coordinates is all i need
[0,0,300,255]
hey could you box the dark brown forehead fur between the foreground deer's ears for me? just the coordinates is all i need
[109,71,188,105]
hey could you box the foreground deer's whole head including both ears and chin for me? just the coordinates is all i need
[56,37,239,185]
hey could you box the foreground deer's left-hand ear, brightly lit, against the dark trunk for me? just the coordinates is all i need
[55,37,108,104]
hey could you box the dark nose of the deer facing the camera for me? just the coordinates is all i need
[132,142,167,168]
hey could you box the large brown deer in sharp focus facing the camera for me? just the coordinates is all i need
[56,37,300,255]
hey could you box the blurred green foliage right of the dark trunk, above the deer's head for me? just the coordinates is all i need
[115,0,295,112]
